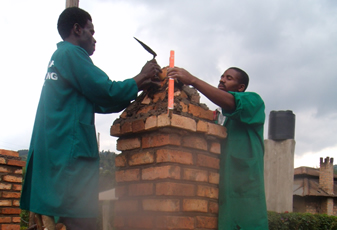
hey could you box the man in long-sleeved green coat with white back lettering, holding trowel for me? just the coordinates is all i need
[20,7,161,230]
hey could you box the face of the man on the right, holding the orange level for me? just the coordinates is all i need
[218,69,245,92]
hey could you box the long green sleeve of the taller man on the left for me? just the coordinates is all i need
[54,45,138,108]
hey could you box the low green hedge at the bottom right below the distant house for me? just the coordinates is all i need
[268,212,337,230]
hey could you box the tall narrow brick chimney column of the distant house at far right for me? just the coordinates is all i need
[319,157,334,215]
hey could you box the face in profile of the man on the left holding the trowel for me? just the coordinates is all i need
[79,20,96,56]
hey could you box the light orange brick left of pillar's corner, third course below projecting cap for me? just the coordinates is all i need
[142,165,180,180]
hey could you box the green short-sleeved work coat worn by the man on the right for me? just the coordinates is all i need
[218,92,268,230]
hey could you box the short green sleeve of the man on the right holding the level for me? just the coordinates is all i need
[222,92,265,124]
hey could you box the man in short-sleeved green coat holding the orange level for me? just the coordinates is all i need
[168,67,268,230]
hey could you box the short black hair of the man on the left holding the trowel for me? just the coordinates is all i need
[57,7,92,40]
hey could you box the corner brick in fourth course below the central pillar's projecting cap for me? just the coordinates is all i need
[156,182,195,196]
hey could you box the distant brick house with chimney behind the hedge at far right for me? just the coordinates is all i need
[293,157,337,216]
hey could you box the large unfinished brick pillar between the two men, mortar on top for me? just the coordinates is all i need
[111,83,226,230]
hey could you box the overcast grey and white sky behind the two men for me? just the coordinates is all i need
[0,0,337,167]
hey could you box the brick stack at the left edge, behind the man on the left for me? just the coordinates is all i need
[0,149,25,230]
